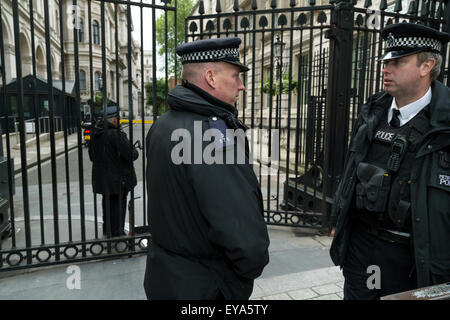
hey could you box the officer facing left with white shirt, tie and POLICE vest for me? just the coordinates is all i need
[330,23,450,299]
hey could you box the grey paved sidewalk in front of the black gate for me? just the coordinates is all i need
[0,226,343,300]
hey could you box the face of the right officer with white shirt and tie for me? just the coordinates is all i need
[382,54,422,99]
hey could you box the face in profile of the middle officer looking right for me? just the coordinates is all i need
[214,62,245,106]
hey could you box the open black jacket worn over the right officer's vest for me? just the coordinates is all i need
[330,81,450,287]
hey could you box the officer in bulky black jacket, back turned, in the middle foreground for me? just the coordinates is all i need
[144,38,269,300]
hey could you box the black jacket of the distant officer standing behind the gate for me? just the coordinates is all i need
[89,121,139,194]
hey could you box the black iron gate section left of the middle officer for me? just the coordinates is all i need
[0,0,176,271]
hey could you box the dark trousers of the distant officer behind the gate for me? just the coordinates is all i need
[102,192,128,237]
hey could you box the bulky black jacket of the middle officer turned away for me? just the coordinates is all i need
[144,83,269,299]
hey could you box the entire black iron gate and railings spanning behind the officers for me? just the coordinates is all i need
[0,0,450,271]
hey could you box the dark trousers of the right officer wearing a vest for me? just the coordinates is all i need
[343,222,417,300]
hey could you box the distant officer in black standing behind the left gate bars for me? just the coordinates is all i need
[89,106,139,237]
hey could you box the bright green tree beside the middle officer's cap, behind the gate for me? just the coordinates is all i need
[156,0,194,79]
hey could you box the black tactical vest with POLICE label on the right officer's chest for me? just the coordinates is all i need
[354,106,430,233]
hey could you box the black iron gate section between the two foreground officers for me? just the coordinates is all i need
[186,0,450,230]
